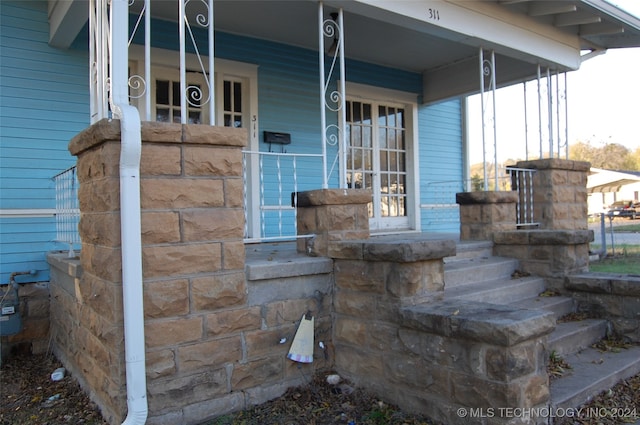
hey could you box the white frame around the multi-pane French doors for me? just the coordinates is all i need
[340,83,420,234]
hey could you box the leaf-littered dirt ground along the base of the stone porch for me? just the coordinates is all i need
[0,356,640,425]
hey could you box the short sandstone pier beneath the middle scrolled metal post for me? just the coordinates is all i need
[297,189,372,257]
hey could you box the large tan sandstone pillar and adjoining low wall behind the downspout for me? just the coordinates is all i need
[47,120,330,425]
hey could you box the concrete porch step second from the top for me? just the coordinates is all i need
[444,253,519,288]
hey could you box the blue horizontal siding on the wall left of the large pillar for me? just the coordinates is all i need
[0,0,89,283]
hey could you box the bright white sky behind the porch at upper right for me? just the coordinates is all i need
[469,0,640,164]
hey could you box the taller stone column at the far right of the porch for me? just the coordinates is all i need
[516,158,591,230]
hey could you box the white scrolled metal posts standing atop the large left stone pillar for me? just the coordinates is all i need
[89,0,216,125]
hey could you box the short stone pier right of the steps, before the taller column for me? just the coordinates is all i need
[456,191,518,240]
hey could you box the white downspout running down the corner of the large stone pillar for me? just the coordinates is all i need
[111,0,148,425]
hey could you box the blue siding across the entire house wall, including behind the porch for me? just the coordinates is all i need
[0,1,462,283]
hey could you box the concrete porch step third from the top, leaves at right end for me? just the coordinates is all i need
[444,276,545,304]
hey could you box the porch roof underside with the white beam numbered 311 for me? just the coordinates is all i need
[49,0,640,102]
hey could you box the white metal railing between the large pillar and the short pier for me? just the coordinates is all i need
[242,151,323,241]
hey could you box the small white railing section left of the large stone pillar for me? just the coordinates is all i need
[53,167,80,258]
